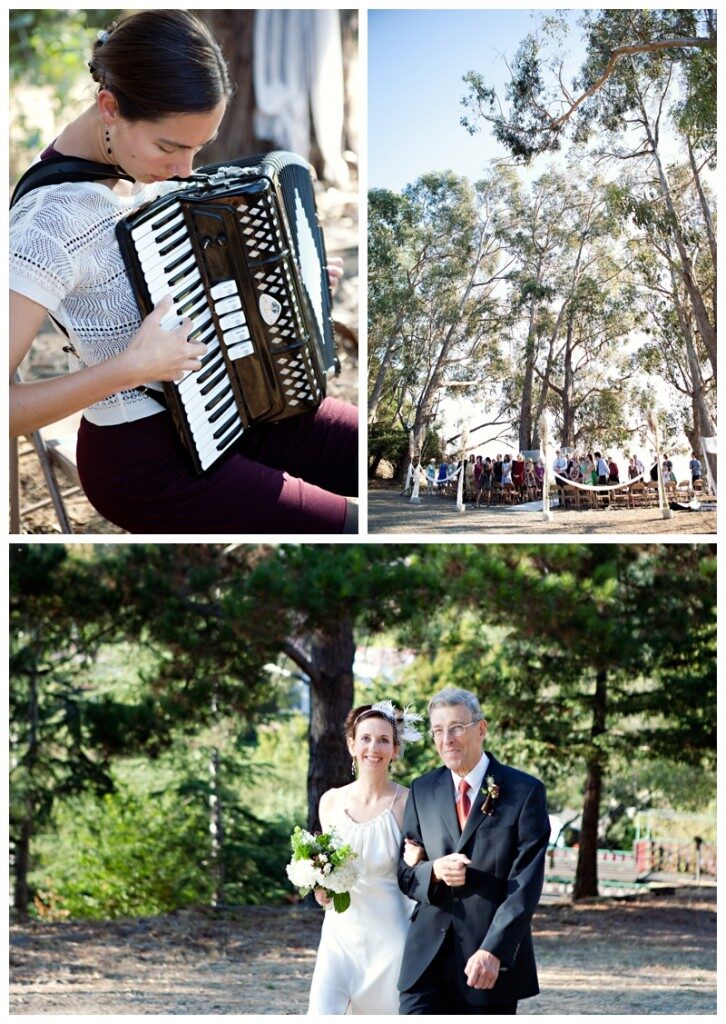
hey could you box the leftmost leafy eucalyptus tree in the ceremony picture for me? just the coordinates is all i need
[369,172,507,468]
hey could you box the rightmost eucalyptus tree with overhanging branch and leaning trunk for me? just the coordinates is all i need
[463,9,717,372]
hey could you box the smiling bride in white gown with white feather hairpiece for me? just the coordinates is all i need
[307,700,423,1015]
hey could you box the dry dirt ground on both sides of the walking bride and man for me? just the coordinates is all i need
[10,889,716,1015]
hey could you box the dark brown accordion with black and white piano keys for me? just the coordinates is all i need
[116,153,338,473]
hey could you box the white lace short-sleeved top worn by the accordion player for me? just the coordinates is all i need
[10,181,178,426]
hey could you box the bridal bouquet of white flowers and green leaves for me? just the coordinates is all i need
[286,825,358,913]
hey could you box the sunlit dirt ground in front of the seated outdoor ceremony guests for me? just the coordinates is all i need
[368,487,717,538]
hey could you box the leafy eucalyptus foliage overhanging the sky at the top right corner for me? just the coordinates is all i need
[462,9,716,163]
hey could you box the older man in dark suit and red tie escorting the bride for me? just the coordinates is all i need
[398,688,550,1015]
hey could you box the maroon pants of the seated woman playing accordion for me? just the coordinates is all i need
[77,398,358,535]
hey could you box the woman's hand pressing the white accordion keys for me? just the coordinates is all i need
[118,295,207,387]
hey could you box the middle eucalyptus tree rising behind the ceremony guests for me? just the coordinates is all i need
[500,170,636,449]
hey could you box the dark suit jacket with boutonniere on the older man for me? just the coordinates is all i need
[398,752,550,1006]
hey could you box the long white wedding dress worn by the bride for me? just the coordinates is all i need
[307,797,416,1015]
